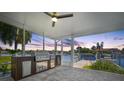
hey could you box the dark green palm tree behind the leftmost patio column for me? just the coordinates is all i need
[0,22,32,50]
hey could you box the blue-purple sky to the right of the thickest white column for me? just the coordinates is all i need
[76,30,124,49]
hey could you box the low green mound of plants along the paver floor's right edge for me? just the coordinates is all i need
[83,60,124,74]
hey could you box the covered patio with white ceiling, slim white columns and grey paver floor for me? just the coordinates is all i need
[0,12,124,81]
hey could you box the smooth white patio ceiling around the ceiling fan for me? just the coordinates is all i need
[0,12,124,39]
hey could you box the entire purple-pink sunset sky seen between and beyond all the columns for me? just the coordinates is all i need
[0,30,124,51]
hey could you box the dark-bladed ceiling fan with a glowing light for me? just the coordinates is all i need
[44,12,73,27]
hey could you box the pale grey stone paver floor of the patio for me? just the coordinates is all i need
[22,66,124,81]
